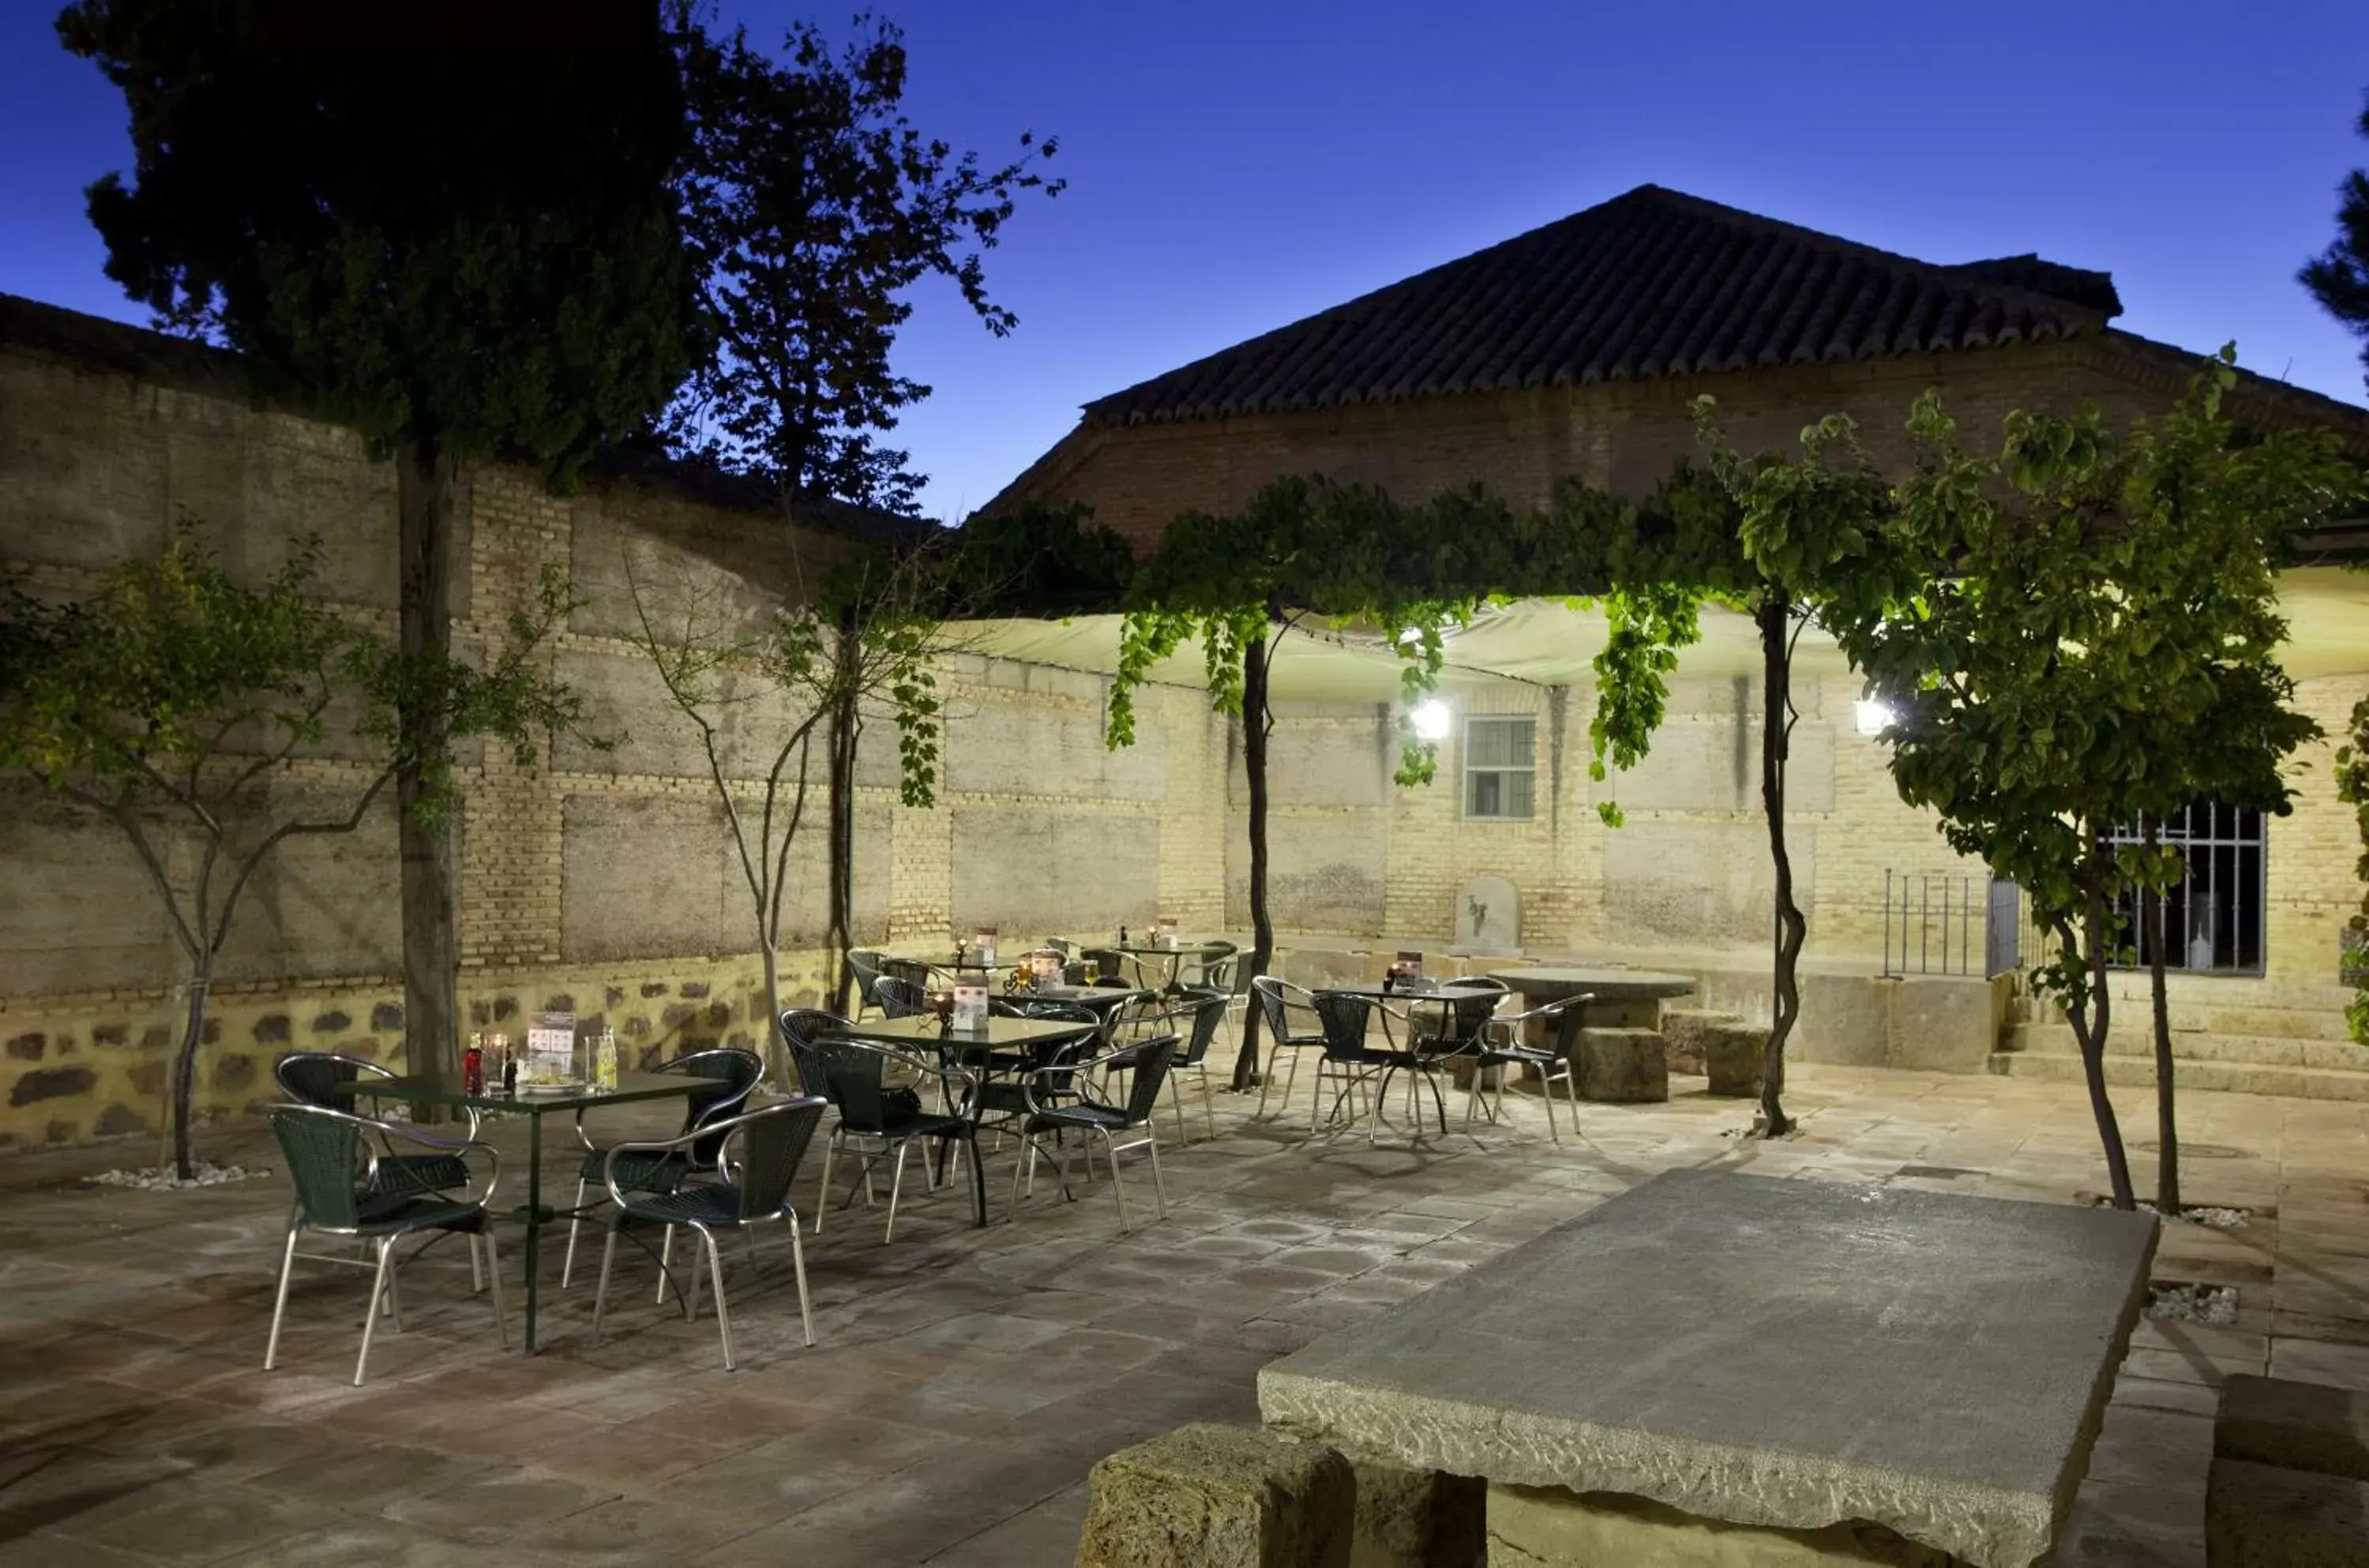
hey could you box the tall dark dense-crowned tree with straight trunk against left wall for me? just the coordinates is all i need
[57,0,689,1090]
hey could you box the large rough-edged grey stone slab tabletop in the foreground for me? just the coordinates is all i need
[1258,1170,2156,1568]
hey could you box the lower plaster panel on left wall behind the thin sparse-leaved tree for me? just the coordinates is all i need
[559,789,888,964]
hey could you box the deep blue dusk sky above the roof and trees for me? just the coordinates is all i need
[0,0,2369,519]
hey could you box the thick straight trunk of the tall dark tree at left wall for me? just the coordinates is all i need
[396,441,460,1090]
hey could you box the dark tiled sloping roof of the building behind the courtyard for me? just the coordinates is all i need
[1085,185,2123,424]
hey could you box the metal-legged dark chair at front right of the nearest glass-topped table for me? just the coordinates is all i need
[592,1094,822,1371]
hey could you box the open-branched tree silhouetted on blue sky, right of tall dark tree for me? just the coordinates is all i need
[668,0,1061,512]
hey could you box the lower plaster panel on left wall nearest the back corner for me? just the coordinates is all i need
[950,801,1161,943]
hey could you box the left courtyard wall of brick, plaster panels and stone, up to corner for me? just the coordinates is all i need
[0,332,1227,1149]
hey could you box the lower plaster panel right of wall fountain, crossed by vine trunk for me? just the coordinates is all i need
[1604,817,1817,947]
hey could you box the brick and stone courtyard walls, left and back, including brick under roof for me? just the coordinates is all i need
[0,310,2362,1146]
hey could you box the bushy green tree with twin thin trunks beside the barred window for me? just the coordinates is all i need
[1744,351,2345,1213]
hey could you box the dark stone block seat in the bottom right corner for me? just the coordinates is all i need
[2206,1374,2369,1568]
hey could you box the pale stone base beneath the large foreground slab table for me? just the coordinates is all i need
[1488,1485,1962,1568]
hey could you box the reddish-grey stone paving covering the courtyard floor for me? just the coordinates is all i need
[0,1066,2369,1568]
